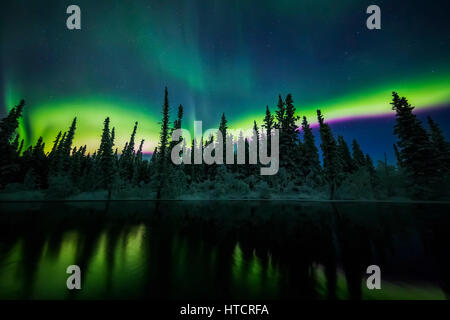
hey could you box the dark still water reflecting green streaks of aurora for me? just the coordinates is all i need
[0,201,450,299]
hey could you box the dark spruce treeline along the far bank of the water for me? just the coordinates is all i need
[0,89,450,199]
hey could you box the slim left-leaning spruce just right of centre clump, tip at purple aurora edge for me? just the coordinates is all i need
[317,110,342,200]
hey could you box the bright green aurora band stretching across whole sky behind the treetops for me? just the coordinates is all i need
[6,74,450,153]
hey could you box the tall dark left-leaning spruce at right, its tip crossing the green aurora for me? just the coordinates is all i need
[391,92,441,199]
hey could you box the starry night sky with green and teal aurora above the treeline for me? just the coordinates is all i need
[0,0,450,161]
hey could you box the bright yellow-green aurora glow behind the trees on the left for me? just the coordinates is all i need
[28,98,159,152]
